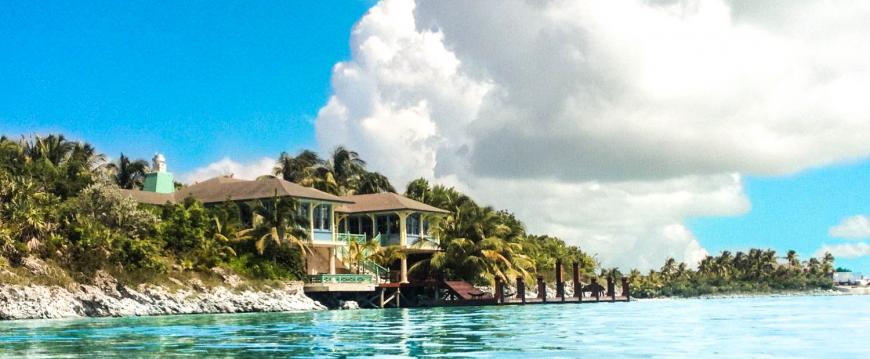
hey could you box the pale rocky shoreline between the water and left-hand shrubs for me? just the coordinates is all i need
[0,276,327,320]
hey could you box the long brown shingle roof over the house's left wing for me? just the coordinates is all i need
[123,177,350,204]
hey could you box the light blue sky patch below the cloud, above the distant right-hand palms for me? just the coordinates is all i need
[689,161,870,274]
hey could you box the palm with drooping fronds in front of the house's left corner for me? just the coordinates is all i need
[254,193,311,265]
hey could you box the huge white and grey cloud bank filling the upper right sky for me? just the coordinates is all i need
[316,0,870,268]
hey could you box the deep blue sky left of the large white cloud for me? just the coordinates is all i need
[0,0,371,171]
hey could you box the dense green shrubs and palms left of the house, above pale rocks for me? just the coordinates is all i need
[0,135,305,279]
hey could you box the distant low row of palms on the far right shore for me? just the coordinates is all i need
[629,249,834,298]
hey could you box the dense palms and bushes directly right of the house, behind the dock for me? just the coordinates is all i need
[405,178,597,284]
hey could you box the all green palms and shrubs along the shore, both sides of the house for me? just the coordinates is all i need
[0,135,833,297]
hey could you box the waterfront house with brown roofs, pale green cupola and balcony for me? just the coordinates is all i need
[123,154,448,291]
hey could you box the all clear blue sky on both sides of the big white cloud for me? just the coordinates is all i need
[0,0,870,272]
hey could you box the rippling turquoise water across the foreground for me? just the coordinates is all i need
[0,296,870,358]
